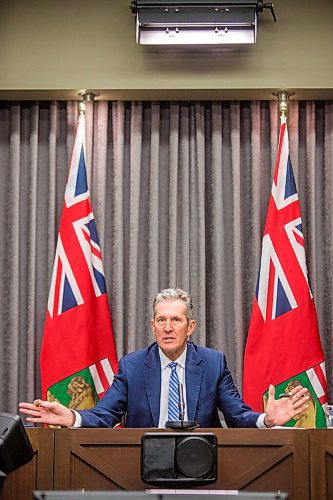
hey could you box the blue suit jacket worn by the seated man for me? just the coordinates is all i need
[79,342,259,427]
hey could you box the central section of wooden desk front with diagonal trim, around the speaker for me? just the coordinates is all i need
[54,429,309,500]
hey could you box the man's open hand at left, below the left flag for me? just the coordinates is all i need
[19,399,75,427]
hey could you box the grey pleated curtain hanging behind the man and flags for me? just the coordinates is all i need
[0,101,333,412]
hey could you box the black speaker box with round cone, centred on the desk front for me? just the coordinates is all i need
[141,432,217,488]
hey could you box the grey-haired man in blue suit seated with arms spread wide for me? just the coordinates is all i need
[20,288,309,427]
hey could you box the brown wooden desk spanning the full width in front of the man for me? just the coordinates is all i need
[0,428,333,500]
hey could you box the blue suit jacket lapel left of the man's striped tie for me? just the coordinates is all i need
[143,344,161,427]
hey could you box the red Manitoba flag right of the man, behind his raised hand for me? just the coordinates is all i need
[243,117,327,427]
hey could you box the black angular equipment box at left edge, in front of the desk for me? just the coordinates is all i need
[0,413,34,473]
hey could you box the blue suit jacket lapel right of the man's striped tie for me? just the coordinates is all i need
[185,342,203,420]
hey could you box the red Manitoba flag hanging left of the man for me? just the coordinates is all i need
[41,111,117,409]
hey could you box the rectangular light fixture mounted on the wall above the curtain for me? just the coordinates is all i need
[131,0,276,45]
